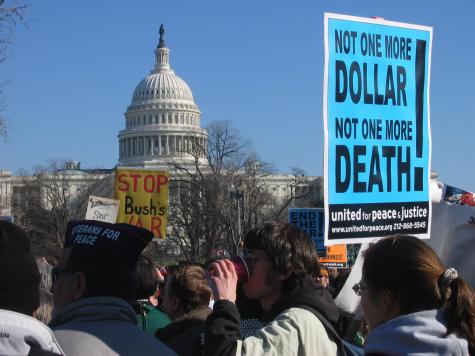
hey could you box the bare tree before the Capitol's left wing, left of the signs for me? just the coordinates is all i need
[13,161,110,256]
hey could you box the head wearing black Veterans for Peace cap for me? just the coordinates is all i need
[51,220,153,307]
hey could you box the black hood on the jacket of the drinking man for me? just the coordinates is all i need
[263,276,340,328]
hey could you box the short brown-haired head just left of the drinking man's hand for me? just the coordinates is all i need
[162,264,211,320]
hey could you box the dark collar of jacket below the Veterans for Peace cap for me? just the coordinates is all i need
[49,297,137,328]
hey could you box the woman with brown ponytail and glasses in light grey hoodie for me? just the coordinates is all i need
[353,236,475,356]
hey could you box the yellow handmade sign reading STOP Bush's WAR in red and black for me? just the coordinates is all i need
[115,168,170,238]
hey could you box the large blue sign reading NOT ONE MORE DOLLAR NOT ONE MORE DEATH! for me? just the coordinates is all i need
[323,14,432,245]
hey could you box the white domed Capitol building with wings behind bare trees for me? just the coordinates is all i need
[0,25,322,219]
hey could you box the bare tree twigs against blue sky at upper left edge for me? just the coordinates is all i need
[0,0,28,138]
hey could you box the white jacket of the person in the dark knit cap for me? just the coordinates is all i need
[0,309,64,355]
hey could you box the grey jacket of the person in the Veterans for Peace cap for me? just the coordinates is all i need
[50,297,175,356]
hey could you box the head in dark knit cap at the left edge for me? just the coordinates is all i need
[0,221,40,315]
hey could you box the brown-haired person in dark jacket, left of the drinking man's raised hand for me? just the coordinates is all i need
[156,263,211,356]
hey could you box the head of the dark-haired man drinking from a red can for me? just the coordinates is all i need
[243,223,320,308]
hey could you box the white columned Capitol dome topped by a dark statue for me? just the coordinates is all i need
[118,25,208,169]
